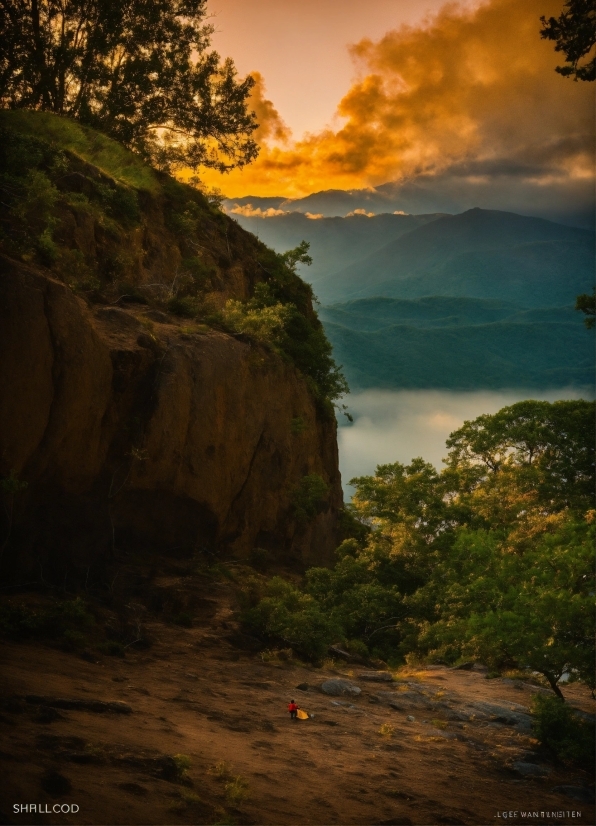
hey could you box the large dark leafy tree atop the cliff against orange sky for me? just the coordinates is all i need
[0,0,258,171]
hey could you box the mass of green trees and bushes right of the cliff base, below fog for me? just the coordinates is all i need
[245,400,596,708]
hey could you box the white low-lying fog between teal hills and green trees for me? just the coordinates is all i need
[338,388,594,499]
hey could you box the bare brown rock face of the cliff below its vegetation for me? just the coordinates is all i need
[0,256,342,579]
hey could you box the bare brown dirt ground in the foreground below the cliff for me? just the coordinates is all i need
[0,568,595,826]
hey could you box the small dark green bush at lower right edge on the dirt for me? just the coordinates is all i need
[532,694,595,769]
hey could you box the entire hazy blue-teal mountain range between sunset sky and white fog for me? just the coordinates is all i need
[227,203,594,389]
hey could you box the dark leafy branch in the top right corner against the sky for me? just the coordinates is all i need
[540,0,596,80]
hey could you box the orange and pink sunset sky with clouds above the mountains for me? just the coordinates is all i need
[202,0,594,216]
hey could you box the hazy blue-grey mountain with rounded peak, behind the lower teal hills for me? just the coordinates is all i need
[315,209,594,307]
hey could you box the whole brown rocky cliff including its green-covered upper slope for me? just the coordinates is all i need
[0,113,342,581]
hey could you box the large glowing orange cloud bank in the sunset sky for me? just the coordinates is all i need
[199,0,593,197]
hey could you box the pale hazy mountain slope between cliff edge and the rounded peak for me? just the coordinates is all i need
[228,207,441,284]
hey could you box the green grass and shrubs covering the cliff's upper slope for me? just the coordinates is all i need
[0,110,346,412]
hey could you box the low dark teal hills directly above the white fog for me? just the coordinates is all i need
[320,296,594,390]
